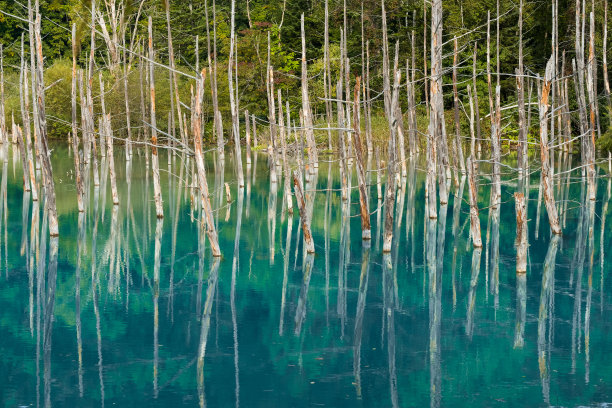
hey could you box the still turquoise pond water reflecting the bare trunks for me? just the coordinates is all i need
[0,146,612,407]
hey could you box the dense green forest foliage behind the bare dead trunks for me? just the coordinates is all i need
[0,0,608,148]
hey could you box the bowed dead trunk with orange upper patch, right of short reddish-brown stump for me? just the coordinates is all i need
[539,58,561,235]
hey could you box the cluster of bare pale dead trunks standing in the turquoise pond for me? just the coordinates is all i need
[0,0,612,272]
